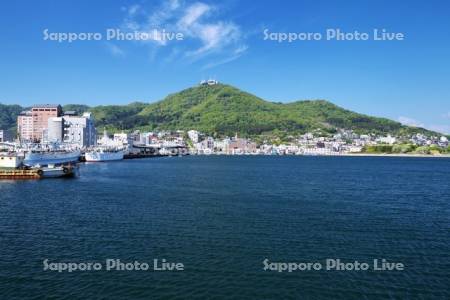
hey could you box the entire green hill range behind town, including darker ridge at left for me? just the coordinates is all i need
[0,84,439,136]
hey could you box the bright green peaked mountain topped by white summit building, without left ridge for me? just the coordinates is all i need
[138,84,436,135]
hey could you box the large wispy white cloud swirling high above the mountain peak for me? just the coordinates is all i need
[115,0,248,67]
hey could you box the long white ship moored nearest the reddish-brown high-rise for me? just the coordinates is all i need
[24,149,81,166]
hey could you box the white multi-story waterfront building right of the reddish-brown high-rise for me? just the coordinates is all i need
[63,112,97,148]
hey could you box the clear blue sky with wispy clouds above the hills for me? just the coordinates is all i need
[0,0,450,133]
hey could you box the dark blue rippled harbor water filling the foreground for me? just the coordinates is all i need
[0,156,450,299]
